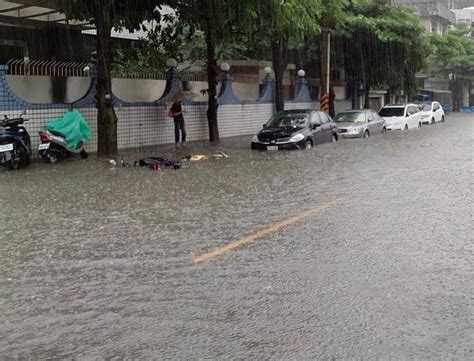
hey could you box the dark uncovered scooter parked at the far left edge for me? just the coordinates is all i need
[0,110,31,170]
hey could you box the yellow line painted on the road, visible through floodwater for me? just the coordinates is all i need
[194,198,344,263]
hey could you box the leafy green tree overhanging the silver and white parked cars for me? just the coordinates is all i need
[337,0,429,108]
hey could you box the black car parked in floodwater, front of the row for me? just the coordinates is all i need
[252,109,338,150]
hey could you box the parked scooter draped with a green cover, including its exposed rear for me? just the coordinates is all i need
[38,110,92,163]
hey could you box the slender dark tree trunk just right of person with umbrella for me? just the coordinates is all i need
[206,31,219,142]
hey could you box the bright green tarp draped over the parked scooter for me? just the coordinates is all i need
[47,110,92,149]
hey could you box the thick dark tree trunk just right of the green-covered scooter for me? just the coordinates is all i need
[96,6,117,156]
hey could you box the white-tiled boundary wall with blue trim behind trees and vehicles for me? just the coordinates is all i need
[0,66,351,156]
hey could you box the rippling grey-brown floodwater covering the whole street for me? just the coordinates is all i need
[0,114,474,360]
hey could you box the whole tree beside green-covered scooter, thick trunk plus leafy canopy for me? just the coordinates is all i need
[55,0,160,156]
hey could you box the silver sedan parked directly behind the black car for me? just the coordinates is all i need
[334,109,387,138]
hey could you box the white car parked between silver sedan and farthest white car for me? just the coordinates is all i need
[379,104,421,130]
